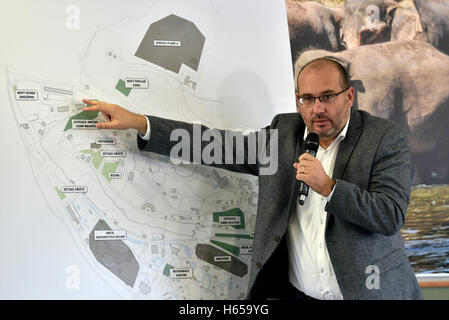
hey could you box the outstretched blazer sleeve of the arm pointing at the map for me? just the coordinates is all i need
[137,116,277,175]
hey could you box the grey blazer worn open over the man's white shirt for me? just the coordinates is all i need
[137,109,422,299]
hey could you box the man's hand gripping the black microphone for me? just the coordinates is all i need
[293,153,335,197]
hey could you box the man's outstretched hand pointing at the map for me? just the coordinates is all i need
[83,99,147,135]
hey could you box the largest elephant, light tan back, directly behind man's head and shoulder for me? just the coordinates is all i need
[296,40,449,185]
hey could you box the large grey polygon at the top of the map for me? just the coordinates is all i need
[135,14,206,73]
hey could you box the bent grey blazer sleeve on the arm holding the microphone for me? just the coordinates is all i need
[325,126,412,236]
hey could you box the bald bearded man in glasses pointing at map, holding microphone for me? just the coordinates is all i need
[84,53,422,300]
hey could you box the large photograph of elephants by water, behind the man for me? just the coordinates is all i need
[286,0,449,274]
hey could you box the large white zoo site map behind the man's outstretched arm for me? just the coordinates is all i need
[0,0,295,299]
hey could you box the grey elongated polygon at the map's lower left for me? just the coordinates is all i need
[89,220,140,288]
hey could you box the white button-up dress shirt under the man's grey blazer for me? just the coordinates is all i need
[287,114,349,300]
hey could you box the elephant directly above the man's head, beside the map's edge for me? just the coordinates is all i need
[286,0,345,63]
